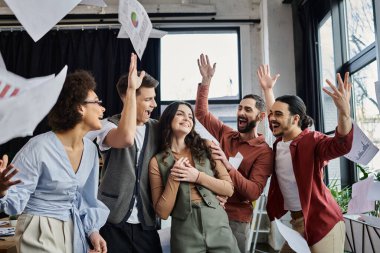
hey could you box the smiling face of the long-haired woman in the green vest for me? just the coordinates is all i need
[171,104,194,135]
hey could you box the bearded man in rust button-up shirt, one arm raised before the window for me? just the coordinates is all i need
[195,54,273,253]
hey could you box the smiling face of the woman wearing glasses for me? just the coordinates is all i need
[81,90,106,131]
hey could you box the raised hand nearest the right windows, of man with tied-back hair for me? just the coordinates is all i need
[322,72,352,118]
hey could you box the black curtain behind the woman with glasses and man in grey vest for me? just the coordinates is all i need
[0,29,160,159]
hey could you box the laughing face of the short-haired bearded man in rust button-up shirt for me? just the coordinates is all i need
[237,98,261,133]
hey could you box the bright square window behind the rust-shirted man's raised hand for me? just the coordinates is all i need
[160,30,240,104]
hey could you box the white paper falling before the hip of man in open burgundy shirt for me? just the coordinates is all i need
[275,219,311,253]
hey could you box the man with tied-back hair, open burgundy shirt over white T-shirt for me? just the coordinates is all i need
[257,65,353,253]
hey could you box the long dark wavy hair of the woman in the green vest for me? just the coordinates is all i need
[158,101,216,175]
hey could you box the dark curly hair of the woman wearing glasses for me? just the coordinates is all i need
[48,70,96,132]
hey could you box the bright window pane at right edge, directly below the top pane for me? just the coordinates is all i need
[351,61,380,171]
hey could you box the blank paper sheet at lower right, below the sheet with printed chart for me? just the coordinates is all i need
[347,176,375,214]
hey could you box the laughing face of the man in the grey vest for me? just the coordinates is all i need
[136,87,157,125]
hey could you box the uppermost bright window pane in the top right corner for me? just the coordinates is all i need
[345,0,377,59]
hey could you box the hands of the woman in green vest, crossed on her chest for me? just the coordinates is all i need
[170,157,200,183]
